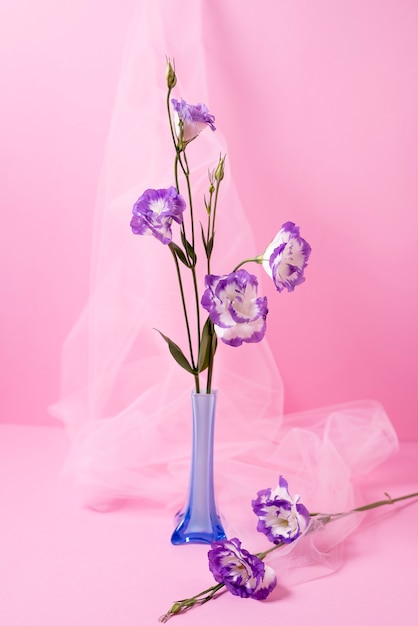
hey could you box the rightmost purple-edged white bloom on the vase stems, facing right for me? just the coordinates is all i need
[262,222,311,291]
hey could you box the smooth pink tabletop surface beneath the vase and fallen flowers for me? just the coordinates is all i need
[0,425,418,626]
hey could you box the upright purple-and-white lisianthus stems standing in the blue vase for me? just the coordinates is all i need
[131,59,311,393]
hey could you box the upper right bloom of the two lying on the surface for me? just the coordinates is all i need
[252,476,310,544]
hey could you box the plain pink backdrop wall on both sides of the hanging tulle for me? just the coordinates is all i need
[0,0,418,439]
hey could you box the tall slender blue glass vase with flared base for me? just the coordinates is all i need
[171,391,226,545]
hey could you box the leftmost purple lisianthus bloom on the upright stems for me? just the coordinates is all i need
[131,187,186,244]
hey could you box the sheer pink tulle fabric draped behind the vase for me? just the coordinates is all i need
[51,0,397,580]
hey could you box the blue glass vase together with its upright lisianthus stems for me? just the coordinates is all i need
[131,60,311,544]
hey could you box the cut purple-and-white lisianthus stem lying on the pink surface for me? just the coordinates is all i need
[158,486,418,623]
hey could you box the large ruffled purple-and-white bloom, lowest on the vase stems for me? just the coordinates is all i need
[202,269,268,346]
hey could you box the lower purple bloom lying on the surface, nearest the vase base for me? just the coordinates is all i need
[208,537,277,600]
